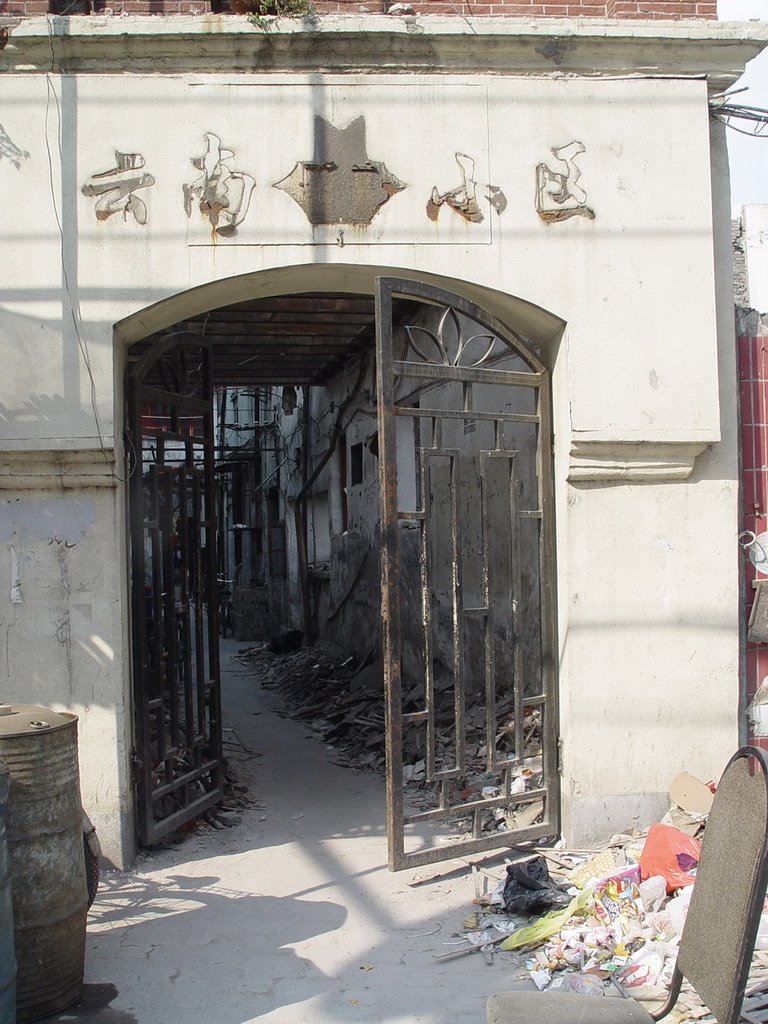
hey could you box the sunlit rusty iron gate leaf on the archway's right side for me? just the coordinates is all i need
[376,278,559,870]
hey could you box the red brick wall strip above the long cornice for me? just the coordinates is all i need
[0,0,717,18]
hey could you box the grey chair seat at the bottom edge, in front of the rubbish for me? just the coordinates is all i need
[485,992,654,1024]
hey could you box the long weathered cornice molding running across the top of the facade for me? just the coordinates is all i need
[0,14,768,90]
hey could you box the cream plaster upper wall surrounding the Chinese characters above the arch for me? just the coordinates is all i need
[0,75,718,443]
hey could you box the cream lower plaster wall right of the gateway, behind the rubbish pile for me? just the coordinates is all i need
[556,116,739,843]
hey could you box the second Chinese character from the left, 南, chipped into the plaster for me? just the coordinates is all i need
[183,132,256,237]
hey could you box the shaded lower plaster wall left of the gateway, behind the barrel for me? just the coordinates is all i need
[0,487,134,863]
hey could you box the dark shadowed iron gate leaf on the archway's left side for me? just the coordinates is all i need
[127,333,223,845]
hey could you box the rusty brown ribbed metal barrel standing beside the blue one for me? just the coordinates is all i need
[0,705,88,1024]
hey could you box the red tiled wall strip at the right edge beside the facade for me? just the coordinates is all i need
[738,335,768,750]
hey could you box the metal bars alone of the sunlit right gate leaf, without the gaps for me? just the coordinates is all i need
[375,278,560,870]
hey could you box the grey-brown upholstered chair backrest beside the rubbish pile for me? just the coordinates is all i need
[677,746,768,1024]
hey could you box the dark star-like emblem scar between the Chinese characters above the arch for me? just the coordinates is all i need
[273,116,407,225]
